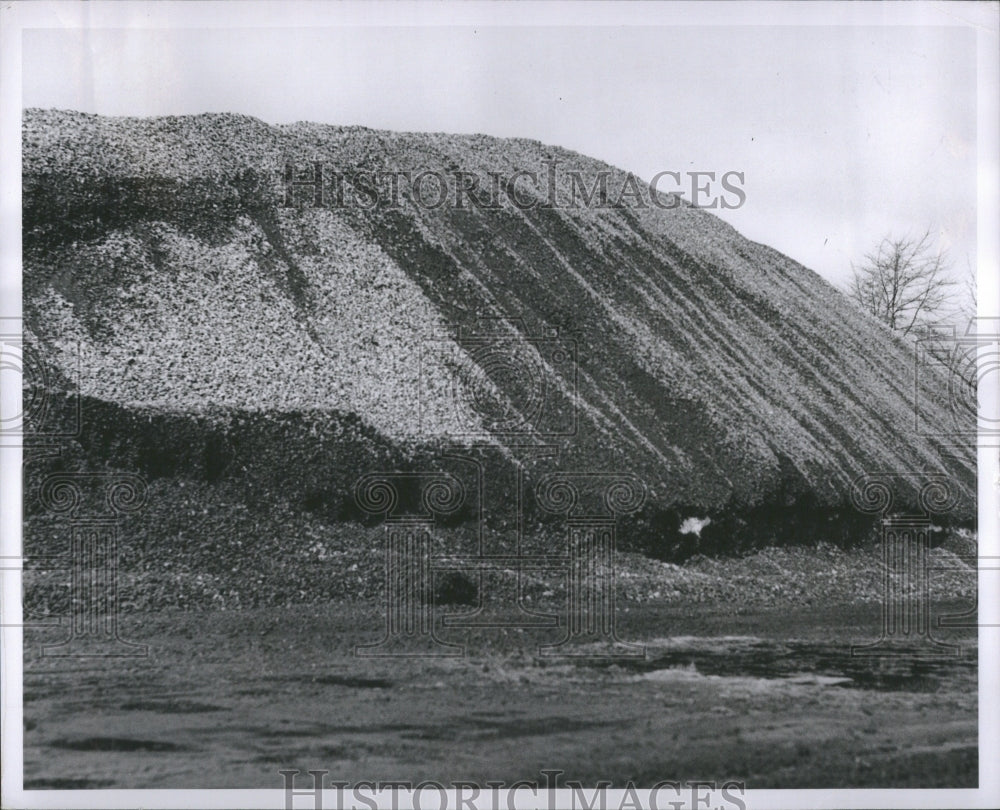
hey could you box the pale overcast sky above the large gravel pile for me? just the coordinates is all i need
[23,21,976,294]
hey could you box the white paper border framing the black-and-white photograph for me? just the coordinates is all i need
[0,0,1000,810]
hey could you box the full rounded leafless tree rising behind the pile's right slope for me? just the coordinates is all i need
[848,231,955,335]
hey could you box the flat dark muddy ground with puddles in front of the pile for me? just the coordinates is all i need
[17,603,978,789]
